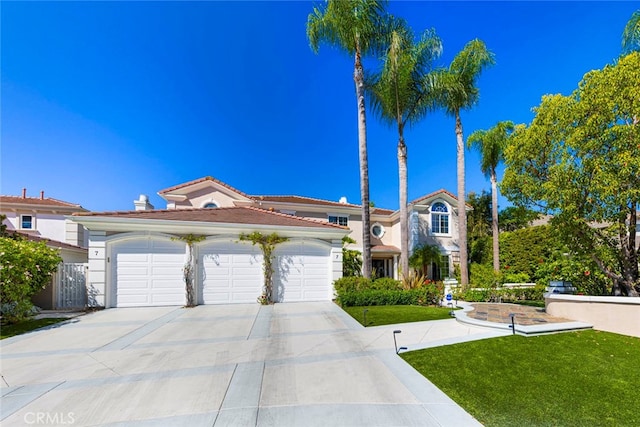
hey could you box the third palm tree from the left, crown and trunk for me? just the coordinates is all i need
[437,39,495,286]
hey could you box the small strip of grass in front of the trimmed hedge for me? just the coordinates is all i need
[342,305,451,326]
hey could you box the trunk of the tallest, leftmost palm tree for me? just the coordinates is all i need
[353,48,372,279]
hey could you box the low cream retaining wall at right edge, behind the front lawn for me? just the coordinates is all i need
[544,293,640,337]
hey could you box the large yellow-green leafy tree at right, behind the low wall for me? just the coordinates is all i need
[503,52,640,296]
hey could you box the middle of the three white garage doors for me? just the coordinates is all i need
[198,241,263,304]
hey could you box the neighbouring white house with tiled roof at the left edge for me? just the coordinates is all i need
[0,189,89,309]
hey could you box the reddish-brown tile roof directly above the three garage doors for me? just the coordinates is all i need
[74,206,348,230]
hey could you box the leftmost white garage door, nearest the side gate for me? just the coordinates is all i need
[112,238,186,307]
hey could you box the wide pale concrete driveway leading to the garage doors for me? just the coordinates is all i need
[0,303,508,426]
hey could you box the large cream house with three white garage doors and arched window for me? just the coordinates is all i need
[70,177,469,307]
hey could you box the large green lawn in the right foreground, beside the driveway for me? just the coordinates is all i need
[401,330,640,426]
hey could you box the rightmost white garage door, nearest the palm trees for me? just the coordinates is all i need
[274,243,332,302]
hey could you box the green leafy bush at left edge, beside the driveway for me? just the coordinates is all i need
[0,237,62,323]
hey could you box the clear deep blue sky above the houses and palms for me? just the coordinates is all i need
[0,1,638,211]
